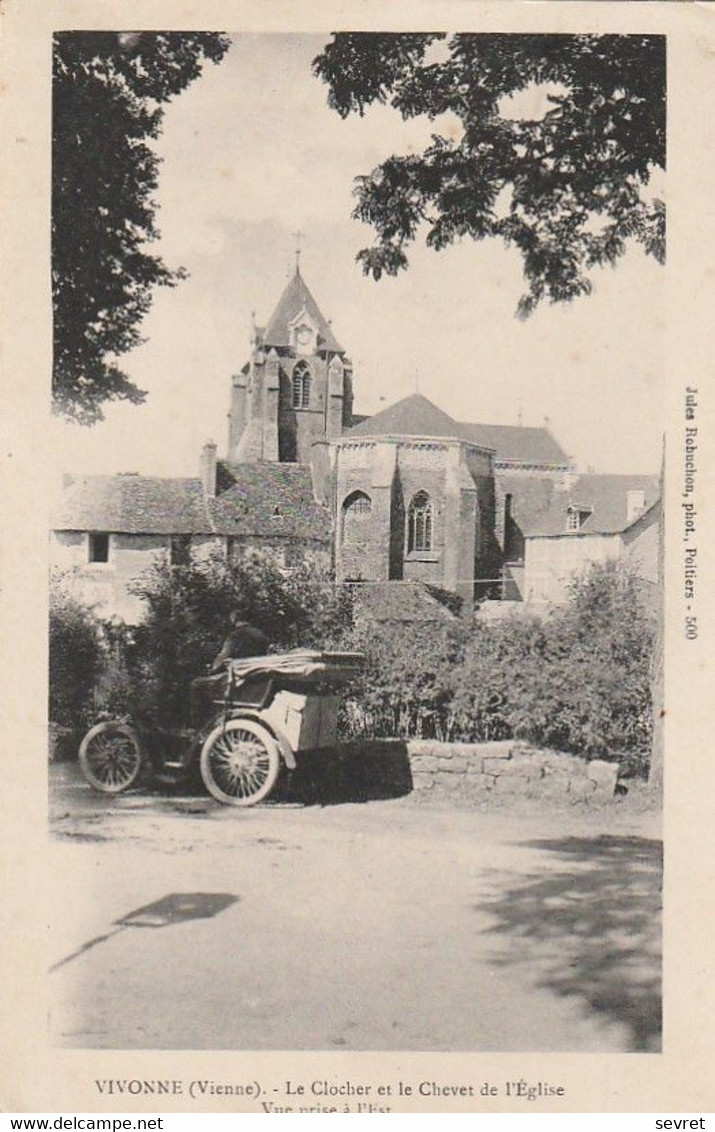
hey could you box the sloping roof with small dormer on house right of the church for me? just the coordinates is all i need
[525,475,660,538]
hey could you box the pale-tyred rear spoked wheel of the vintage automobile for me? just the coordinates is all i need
[201,719,281,806]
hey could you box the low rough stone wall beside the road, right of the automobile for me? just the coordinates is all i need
[405,739,619,801]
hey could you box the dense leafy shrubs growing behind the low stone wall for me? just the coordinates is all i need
[346,563,655,771]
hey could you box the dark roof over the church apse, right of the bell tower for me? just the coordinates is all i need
[345,393,568,465]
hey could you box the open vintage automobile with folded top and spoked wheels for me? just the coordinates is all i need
[79,651,362,806]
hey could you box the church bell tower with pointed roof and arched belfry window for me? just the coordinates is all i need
[229,267,352,463]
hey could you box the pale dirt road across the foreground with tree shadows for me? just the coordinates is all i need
[51,767,660,1052]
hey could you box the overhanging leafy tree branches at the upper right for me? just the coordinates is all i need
[313,33,665,317]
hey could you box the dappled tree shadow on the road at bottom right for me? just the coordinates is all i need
[477,835,662,1053]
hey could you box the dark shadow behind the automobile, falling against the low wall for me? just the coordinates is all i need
[272,739,413,806]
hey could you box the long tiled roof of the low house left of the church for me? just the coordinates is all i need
[52,461,330,542]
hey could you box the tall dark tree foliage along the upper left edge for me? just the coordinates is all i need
[52,32,230,425]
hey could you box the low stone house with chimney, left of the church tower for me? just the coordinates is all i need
[51,444,331,624]
